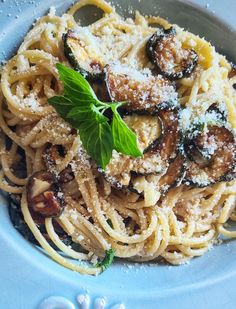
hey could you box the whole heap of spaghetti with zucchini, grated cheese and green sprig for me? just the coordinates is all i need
[0,0,236,275]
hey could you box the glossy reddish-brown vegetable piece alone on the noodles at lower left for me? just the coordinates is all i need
[26,171,64,217]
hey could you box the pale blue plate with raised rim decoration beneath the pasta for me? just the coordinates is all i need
[0,0,236,309]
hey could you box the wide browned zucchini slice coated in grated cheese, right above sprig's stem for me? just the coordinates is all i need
[104,64,177,113]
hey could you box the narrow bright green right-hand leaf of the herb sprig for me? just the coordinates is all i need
[111,104,142,157]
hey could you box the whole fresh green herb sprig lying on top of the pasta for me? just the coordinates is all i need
[48,63,142,169]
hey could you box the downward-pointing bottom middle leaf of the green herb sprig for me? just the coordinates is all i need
[79,117,114,169]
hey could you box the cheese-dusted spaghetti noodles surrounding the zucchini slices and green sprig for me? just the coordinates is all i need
[0,0,236,274]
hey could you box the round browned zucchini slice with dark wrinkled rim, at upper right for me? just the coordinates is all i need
[146,28,198,80]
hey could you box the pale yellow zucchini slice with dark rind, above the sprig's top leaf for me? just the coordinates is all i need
[63,30,104,79]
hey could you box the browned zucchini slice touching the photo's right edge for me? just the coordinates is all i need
[185,125,236,187]
